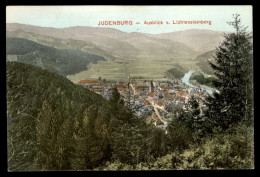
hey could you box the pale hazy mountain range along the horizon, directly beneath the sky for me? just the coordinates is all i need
[7,23,229,60]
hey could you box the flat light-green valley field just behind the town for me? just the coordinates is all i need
[67,59,203,82]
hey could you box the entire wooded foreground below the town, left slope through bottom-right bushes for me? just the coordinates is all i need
[6,62,253,171]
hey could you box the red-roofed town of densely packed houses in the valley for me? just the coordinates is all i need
[76,80,209,128]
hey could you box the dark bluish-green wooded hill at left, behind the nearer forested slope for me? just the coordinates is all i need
[6,38,105,76]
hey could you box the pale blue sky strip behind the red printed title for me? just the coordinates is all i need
[6,6,252,34]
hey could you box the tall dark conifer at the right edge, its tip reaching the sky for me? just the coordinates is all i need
[207,14,253,129]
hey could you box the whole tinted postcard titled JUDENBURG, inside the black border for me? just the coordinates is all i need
[6,5,255,172]
